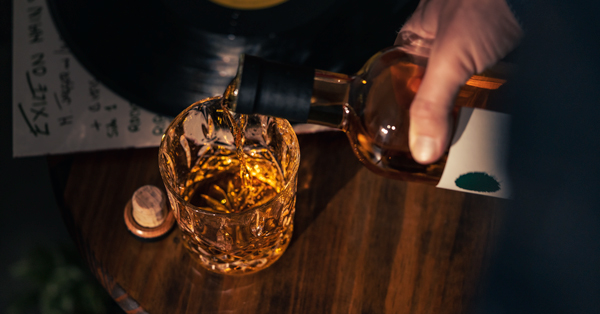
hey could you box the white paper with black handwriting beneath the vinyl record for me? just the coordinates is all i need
[13,0,171,157]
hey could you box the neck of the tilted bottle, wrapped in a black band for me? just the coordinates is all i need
[223,55,353,128]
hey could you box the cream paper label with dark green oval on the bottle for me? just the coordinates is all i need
[437,108,511,198]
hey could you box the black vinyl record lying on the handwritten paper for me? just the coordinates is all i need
[48,0,416,116]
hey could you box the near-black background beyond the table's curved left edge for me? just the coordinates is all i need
[0,0,122,313]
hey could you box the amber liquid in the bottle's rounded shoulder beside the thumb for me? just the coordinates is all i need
[309,50,446,183]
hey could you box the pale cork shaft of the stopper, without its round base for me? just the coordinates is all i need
[131,185,167,228]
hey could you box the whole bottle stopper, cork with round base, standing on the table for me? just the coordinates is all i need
[124,185,175,240]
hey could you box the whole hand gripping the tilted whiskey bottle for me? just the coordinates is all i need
[396,0,522,164]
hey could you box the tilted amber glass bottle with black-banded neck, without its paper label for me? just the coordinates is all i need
[224,32,504,184]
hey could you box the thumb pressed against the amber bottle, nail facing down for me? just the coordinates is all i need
[408,51,470,164]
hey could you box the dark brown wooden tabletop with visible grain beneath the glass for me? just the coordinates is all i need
[49,132,502,314]
